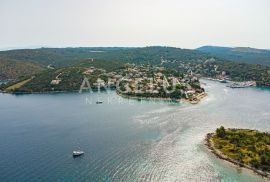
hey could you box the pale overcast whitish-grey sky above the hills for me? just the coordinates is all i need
[0,0,270,50]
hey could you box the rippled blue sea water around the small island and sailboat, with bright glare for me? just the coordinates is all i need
[0,81,270,182]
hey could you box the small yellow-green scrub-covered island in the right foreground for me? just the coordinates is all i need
[206,126,270,178]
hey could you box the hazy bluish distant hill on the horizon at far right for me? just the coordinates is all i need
[196,46,270,65]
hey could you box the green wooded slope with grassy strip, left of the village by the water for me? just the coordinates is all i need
[0,60,124,93]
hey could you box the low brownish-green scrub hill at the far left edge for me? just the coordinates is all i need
[0,58,44,80]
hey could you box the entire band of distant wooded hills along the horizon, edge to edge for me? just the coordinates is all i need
[0,46,270,67]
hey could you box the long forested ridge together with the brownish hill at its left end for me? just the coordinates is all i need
[0,46,213,79]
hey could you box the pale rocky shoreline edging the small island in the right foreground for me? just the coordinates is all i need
[205,133,270,179]
